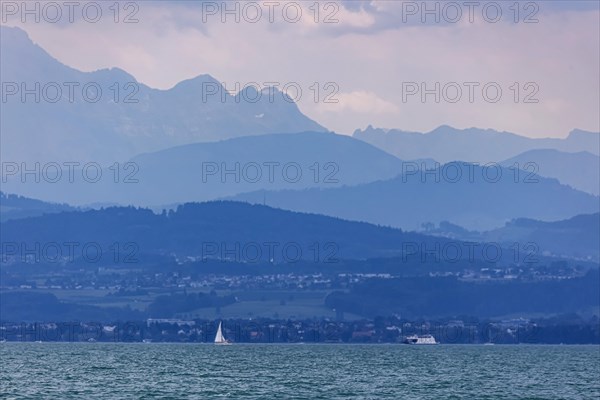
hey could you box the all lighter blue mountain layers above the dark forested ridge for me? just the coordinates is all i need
[0,26,600,231]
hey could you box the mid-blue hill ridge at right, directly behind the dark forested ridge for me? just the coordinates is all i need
[232,163,600,230]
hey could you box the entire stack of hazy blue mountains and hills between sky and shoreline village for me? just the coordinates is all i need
[0,18,600,321]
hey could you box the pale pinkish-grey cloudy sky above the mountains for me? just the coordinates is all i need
[2,0,600,137]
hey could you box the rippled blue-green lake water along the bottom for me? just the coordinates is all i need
[0,342,600,399]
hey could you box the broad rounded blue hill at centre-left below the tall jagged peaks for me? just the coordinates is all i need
[3,132,403,206]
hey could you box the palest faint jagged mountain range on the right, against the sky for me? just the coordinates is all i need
[353,125,600,164]
